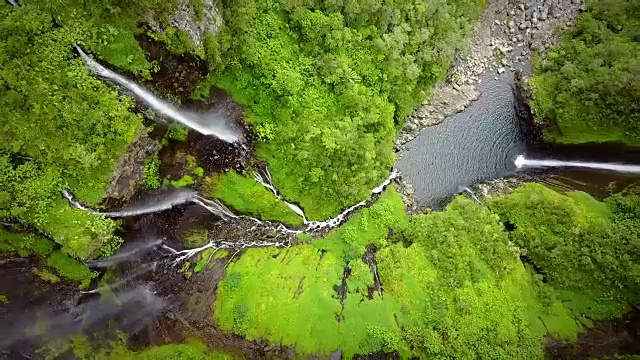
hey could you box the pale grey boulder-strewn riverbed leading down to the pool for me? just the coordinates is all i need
[395,0,584,151]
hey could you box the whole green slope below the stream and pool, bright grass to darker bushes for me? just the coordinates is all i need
[214,184,640,359]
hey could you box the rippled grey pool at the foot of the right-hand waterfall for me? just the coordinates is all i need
[397,73,525,207]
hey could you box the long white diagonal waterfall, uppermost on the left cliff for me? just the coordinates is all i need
[75,46,241,143]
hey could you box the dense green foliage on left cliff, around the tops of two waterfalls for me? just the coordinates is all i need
[0,1,178,258]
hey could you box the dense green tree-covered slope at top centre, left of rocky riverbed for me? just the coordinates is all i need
[205,0,484,219]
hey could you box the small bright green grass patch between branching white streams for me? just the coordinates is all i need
[204,170,302,225]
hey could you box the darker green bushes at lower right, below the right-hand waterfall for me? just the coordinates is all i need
[491,184,640,318]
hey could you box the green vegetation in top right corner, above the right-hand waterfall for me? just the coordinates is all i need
[531,0,640,145]
